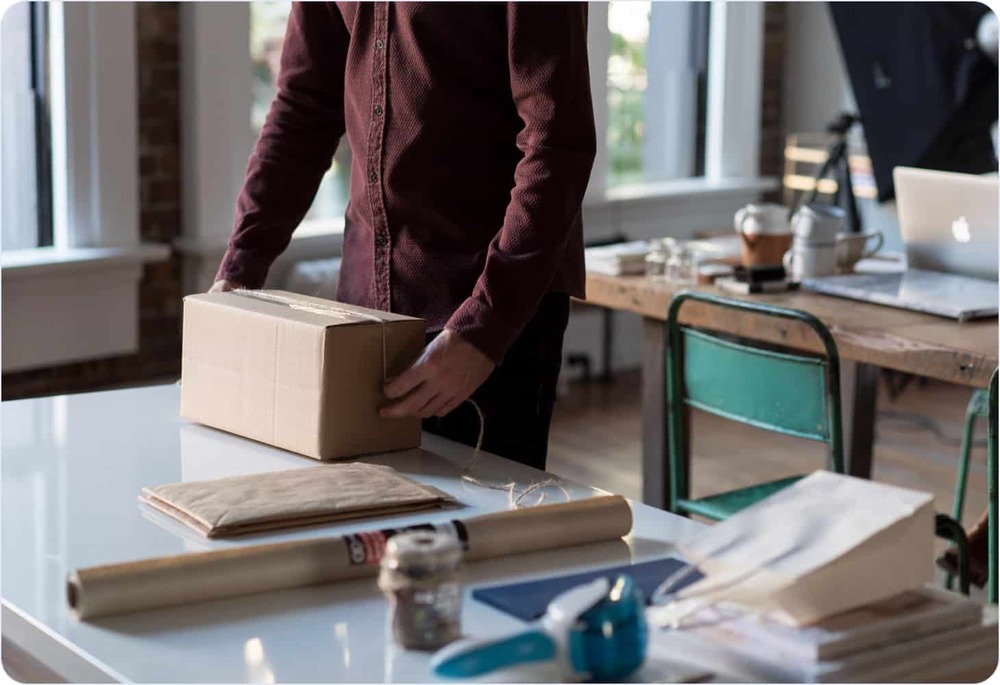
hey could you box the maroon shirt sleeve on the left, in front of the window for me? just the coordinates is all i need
[216,2,350,288]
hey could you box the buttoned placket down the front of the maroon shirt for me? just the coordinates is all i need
[365,2,392,311]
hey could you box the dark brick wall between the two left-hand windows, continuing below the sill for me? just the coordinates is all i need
[2,2,181,400]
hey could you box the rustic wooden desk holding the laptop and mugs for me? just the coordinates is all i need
[587,273,998,507]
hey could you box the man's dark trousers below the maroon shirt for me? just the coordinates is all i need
[424,293,569,470]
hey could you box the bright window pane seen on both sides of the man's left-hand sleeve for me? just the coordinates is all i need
[250,2,351,230]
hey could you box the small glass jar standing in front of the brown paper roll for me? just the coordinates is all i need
[378,530,462,650]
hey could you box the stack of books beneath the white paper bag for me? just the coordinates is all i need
[649,587,998,683]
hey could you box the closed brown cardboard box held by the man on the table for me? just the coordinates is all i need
[181,290,426,459]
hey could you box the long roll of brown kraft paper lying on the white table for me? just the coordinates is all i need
[66,495,632,619]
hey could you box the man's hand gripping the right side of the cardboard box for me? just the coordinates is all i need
[379,329,495,419]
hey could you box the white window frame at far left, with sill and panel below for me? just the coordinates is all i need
[0,0,170,373]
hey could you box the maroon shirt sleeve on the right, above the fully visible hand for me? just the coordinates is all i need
[446,2,596,363]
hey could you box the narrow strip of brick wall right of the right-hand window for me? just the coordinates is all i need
[760,2,788,201]
